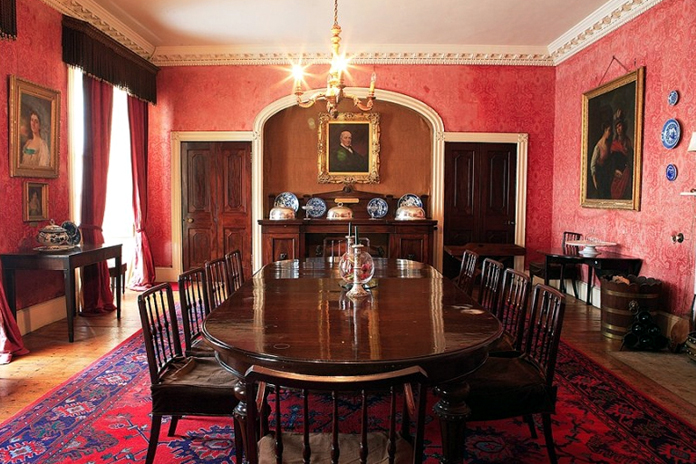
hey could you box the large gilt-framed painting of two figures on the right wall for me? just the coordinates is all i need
[581,68,645,211]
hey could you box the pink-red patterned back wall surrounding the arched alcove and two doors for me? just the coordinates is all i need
[148,65,555,267]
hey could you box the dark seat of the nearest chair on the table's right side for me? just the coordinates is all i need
[466,357,556,421]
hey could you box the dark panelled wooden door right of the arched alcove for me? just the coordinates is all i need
[444,143,517,245]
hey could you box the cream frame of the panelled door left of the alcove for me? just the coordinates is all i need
[166,131,254,282]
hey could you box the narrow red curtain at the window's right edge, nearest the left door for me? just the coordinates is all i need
[128,95,155,290]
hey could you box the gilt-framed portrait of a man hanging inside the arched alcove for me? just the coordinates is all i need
[318,113,380,184]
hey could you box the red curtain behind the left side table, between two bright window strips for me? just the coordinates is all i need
[80,75,116,315]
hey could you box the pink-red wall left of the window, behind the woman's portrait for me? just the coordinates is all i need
[0,0,70,314]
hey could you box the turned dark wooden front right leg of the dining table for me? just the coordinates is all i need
[433,382,471,464]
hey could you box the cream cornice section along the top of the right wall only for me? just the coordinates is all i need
[549,0,662,65]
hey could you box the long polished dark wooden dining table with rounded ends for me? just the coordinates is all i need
[203,259,502,463]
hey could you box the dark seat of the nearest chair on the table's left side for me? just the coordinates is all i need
[151,357,239,416]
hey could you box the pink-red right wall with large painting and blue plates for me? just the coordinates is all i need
[550,0,696,319]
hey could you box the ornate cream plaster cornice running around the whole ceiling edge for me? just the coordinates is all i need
[42,0,662,67]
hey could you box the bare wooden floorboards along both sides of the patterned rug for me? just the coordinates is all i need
[0,291,696,427]
